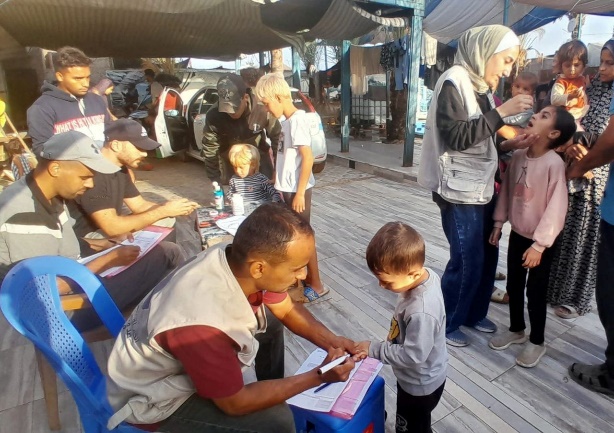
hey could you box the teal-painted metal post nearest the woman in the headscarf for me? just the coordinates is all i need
[403,9,424,167]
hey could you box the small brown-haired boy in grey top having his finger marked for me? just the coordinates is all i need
[357,222,448,433]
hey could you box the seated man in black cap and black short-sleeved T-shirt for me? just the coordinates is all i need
[70,119,198,237]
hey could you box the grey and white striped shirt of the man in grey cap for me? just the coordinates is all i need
[0,173,80,280]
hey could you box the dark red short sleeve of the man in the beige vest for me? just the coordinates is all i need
[155,325,243,399]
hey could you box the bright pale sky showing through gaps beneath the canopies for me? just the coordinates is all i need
[192,15,614,69]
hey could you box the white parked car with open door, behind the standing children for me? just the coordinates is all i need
[154,86,327,173]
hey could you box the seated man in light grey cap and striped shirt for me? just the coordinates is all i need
[0,131,183,331]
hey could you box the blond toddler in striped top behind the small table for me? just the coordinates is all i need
[228,144,281,203]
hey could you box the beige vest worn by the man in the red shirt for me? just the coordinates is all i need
[107,244,266,429]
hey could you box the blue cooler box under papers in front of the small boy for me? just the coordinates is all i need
[290,376,385,433]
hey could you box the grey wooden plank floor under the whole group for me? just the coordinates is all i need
[0,161,614,433]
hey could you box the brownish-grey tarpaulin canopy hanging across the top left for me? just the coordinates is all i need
[0,0,405,59]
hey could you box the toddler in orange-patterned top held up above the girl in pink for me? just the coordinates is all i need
[551,40,589,122]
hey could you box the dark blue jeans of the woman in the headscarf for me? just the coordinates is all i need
[433,193,499,333]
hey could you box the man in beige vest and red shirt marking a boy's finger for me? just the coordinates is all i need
[107,203,358,433]
